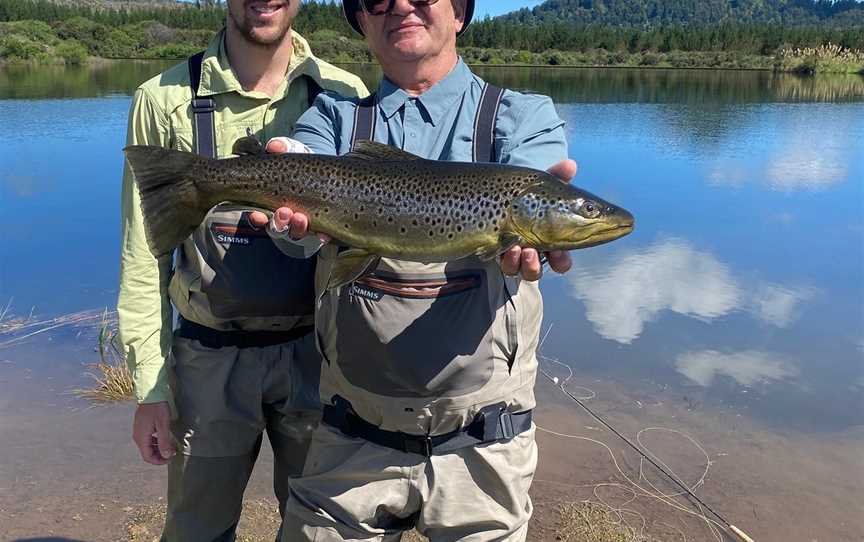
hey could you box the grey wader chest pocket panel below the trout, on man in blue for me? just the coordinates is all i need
[335,269,495,397]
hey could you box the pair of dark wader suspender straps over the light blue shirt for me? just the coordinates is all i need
[350,83,504,162]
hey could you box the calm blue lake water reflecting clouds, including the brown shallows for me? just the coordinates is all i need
[0,63,864,542]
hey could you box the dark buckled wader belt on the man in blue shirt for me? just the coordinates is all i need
[322,395,533,457]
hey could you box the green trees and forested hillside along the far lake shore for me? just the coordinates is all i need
[0,0,864,73]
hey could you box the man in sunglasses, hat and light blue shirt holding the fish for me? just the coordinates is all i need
[256,0,575,542]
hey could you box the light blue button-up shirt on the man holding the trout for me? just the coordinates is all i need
[293,58,567,170]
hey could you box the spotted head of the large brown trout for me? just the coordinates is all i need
[510,174,634,250]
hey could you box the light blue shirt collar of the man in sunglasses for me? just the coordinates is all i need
[378,57,473,125]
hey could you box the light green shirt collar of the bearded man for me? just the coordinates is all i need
[198,28,315,100]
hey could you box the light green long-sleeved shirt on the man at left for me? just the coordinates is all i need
[117,31,368,403]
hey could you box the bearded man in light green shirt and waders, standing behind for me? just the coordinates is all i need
[117,0,367,542]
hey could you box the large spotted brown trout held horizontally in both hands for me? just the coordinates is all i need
[124,141,634,287]
